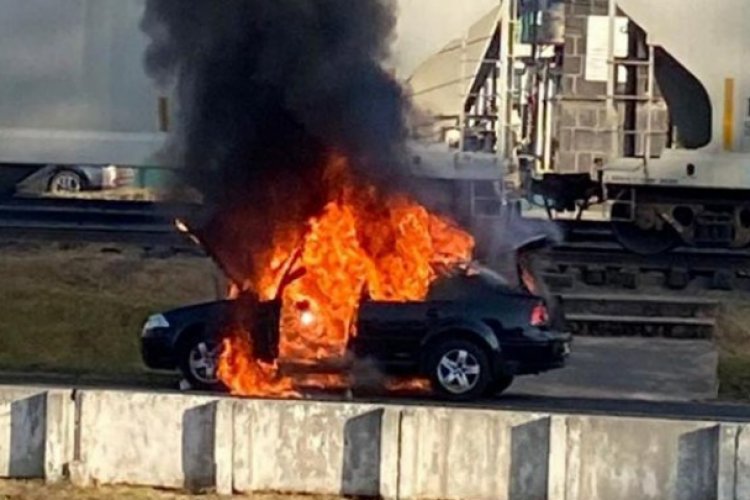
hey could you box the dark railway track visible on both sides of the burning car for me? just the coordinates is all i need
[0,198,750,289]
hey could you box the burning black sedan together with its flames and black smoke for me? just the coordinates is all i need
[135,0,568,399]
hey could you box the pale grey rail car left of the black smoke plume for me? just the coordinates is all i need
[0,0,167,193]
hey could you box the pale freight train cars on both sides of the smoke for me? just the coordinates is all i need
[0,0,750,254]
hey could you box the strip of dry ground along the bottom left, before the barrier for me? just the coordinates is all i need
[0,480,340,500]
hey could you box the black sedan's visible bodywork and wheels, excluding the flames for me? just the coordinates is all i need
[141,265,571,400]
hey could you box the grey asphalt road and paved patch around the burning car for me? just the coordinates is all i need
[0,337,750,421]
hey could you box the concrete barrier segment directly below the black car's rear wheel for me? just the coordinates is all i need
[398,408,550,500]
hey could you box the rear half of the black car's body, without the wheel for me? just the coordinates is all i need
[350,274,571,376]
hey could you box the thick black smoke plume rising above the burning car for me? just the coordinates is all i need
[142,0,406,282]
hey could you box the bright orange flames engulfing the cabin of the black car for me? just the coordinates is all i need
[219,157,474,396]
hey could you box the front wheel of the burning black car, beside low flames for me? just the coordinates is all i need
[178,335,225,391]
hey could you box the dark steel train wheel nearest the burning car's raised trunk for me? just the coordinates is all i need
[611,202,680,255]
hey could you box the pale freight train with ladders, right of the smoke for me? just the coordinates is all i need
[408,0,750,254]
